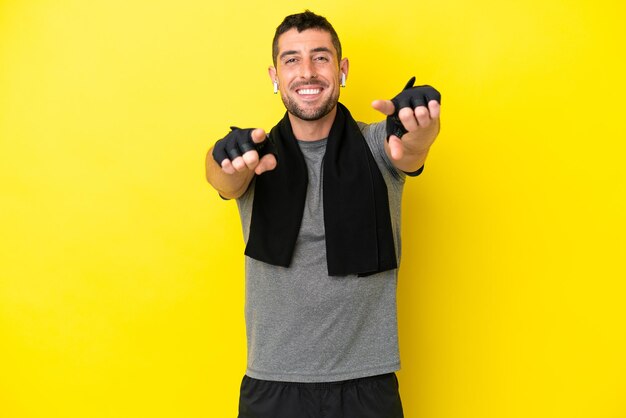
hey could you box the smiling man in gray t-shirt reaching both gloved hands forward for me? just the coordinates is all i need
[206,10,440,418]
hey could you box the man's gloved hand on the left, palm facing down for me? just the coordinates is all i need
[212,126,276,174]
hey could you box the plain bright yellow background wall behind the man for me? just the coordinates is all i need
[0,0,626,418]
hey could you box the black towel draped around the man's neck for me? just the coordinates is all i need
[245,103,397,276]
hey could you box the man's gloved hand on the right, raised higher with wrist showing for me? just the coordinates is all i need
[372,77,441,166]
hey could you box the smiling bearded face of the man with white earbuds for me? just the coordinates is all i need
[270,29,348,121]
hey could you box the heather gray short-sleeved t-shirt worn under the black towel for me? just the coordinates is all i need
[237,122,405,382]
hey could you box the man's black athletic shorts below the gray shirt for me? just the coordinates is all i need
[239,373,404,418]
